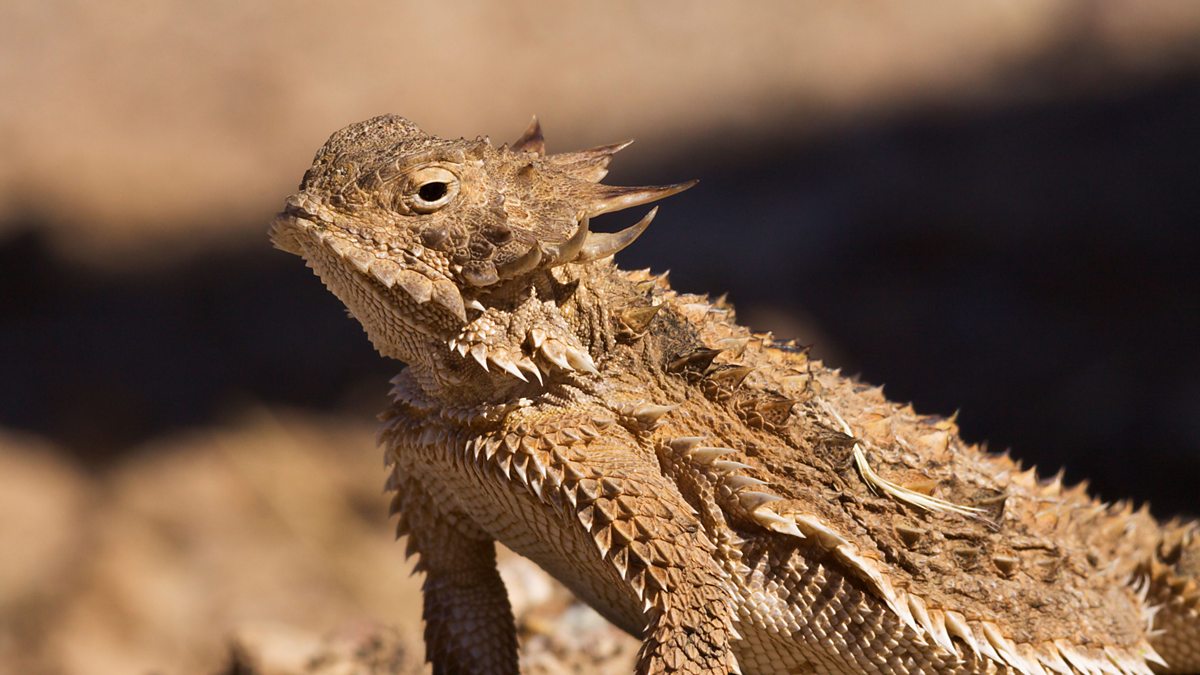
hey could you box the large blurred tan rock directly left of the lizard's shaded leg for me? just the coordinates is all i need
[39,412,429,673]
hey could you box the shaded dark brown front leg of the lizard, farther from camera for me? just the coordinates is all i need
[394,478,517,675]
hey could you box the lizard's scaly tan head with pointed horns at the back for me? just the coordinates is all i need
[271,115,694,384]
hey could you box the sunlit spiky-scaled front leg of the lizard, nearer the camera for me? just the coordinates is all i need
[477,403,738,675]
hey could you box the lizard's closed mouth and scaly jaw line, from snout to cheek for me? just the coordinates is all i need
[271,195,467,329]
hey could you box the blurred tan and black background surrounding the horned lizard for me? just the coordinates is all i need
[0,0,1200,673]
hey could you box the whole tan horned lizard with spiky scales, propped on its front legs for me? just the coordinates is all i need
[272,115,1200,674]
